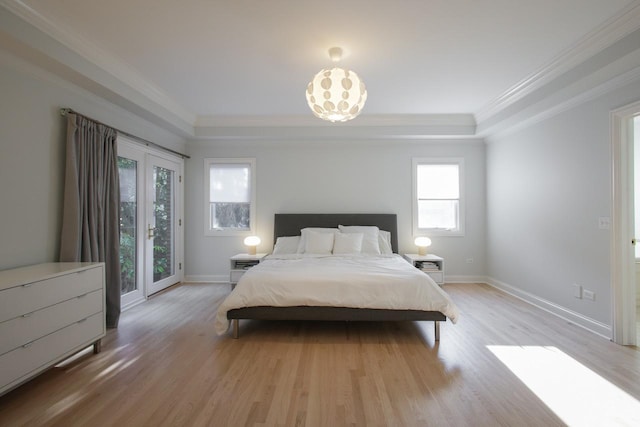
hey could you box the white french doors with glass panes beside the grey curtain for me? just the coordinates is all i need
[118,137,182,309]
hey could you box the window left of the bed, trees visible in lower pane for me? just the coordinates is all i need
[204,159,256,236]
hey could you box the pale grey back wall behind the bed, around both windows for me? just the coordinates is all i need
[185,140,486,281]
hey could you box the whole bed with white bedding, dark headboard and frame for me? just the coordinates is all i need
[215,214,458,340]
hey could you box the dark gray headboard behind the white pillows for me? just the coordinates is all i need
[273,214,398,253]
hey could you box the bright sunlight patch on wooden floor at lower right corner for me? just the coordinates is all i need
[487,345,640,426]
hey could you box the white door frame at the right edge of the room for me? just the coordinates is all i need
[610,101,640,345]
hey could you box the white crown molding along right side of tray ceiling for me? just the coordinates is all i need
[475,0,640,123]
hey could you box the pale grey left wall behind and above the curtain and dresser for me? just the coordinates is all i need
[0,50,185,269]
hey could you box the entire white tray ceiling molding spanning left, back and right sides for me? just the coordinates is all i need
[0,0,640,140]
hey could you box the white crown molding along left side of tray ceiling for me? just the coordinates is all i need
[0,0,196,133]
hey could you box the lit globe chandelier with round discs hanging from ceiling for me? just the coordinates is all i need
[306,47,367,122]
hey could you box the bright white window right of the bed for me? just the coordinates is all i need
[413,158,464,236]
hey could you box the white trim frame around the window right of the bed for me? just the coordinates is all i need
[411,157,466,237]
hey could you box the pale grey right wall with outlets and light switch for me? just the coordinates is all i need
[487,77,640,335]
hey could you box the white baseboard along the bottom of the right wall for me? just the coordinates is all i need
[486,277,613,340]
